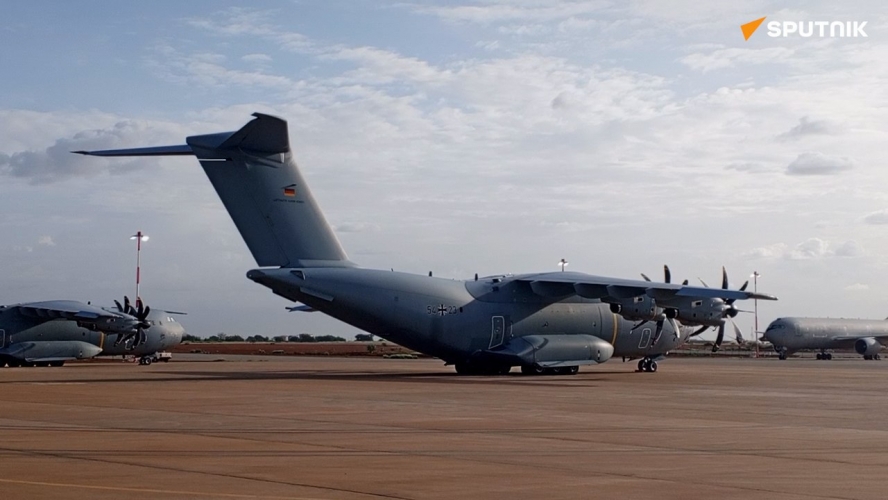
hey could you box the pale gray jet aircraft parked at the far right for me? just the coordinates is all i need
[762,318,888,360]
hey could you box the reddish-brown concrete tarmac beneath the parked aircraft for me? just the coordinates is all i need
[0,355,888,500]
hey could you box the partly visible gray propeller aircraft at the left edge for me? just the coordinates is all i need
[0,299,185,367]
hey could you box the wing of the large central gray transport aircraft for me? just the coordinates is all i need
[518,272,777,301]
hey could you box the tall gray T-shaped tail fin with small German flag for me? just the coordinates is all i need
[81,113,354,267]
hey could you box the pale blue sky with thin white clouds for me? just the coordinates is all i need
[0,0,888,335]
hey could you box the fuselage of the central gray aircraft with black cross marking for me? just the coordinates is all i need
[247,268,687,363]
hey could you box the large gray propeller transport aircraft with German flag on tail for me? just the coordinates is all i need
[76,113,775,374]
